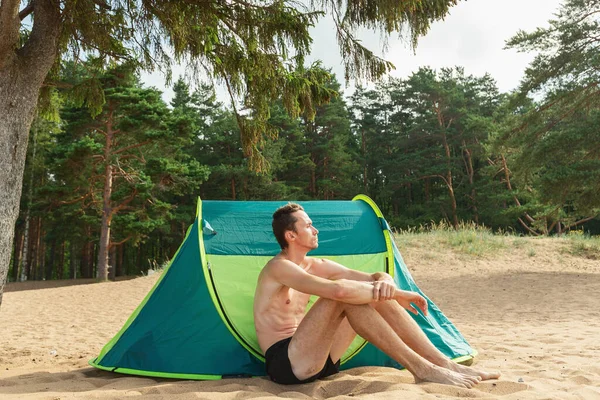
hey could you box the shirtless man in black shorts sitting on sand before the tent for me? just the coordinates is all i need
[254,203,500,388]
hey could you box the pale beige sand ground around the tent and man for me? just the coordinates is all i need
[0,239,600,400]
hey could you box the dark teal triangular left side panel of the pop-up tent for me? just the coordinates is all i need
[96,220,264,375]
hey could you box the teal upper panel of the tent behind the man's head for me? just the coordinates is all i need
[202,201,386,257]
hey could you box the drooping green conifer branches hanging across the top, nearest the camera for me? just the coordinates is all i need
[14,0,457,172]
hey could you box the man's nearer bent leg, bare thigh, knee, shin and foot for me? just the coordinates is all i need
[288,299,480,387]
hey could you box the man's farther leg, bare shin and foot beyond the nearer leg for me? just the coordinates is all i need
[371,300,500,380]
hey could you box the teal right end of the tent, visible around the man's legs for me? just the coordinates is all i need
[342,234,475,369]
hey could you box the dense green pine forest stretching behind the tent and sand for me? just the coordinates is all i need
[8,1,600,281]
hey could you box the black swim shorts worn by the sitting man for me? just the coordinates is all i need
[265,337,340,385]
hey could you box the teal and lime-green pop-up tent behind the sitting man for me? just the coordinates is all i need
[90,195,475,379]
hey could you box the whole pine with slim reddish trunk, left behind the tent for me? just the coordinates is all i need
[56,64,206,280]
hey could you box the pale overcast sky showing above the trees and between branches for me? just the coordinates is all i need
[142,0,561,102]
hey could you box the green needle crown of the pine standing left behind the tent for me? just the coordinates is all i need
[40,64,208,266]
